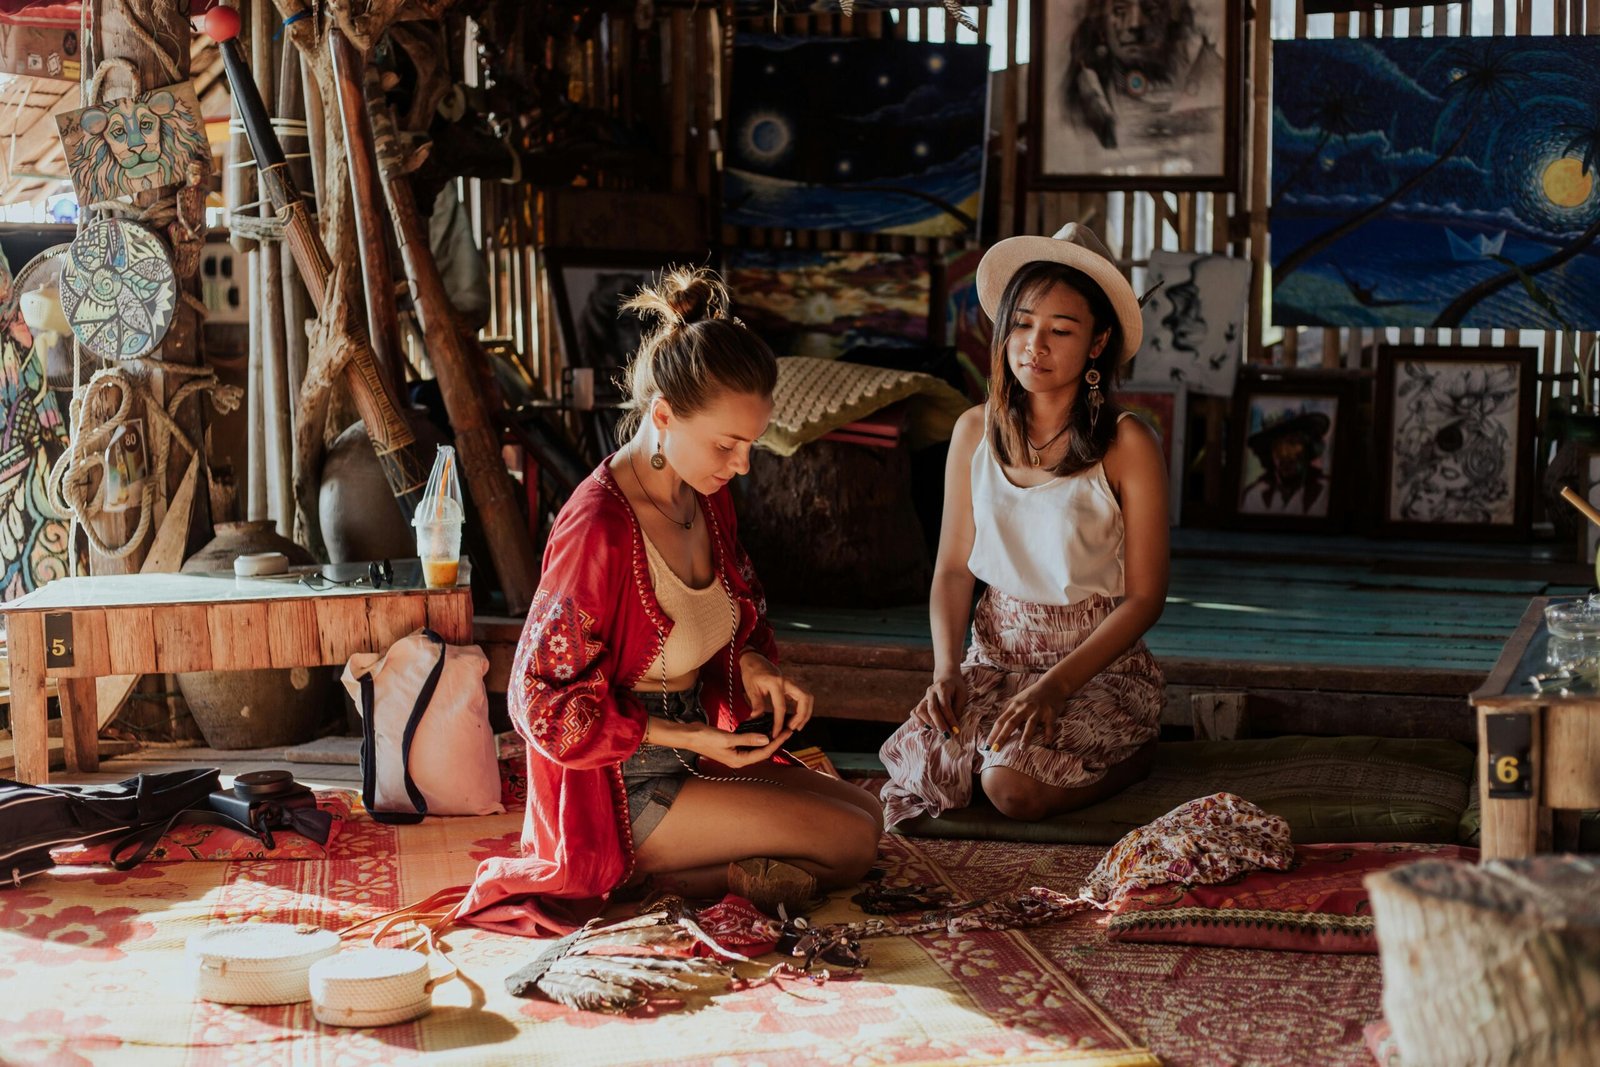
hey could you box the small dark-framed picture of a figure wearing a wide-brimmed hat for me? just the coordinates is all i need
[1227,370,1360,533]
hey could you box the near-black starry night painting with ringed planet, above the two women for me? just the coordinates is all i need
[722,35,989,237]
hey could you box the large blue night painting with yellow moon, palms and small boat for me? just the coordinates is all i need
[1272,37,1600,330]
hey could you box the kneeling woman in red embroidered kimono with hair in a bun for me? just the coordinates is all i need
[456,270,883,936]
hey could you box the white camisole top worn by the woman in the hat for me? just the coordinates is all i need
[966,413,1128,605]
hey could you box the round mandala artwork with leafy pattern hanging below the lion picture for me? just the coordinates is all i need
[61,219,178,360]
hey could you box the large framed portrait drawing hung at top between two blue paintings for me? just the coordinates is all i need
[1029,0,1243,192]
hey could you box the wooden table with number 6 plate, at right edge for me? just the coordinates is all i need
[1470,597,1600,859]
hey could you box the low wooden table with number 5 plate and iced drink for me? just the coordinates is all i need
[0,560,472,782]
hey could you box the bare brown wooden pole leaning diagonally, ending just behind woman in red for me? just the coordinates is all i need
[366,74,539,614]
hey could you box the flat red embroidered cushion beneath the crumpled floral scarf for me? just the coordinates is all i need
[1106,845,1477,953]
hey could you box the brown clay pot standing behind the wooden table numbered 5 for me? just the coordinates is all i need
[178,522,339,749]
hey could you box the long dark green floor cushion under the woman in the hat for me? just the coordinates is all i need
[893,737,1474,845]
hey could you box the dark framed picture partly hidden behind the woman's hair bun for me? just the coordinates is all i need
[544,248,707,462]
